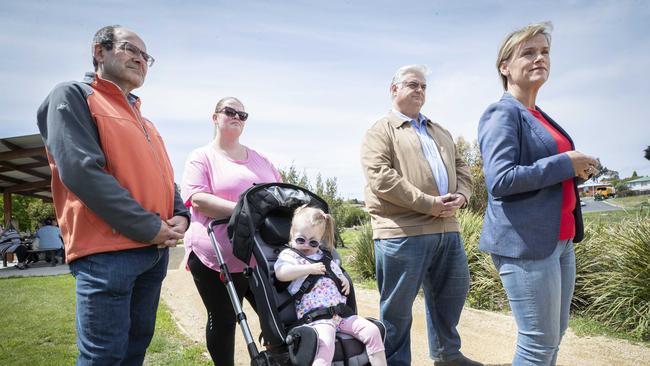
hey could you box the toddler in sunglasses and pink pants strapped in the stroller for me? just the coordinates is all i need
[274,205,386,366]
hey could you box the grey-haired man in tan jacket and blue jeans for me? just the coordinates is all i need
[361,65,480,366]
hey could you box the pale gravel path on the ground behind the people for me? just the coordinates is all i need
[162,269,650,366]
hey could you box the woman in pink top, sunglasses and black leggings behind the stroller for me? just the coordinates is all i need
[181,97,281,366]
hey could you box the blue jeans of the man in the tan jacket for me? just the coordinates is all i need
[375,232,469,366]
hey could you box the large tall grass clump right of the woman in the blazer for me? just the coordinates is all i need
[574,215,650,340]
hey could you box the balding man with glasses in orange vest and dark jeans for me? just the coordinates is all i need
[38,25,189,365]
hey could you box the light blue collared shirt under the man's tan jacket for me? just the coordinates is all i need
[393,108,449,196]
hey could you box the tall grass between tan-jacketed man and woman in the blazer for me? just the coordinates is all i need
[458,210,508,310]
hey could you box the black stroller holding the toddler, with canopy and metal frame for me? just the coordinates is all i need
[208,183,385,366]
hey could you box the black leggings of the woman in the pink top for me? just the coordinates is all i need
[187,252,255,366]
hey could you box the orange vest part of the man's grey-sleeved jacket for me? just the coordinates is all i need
[48,77,174,263]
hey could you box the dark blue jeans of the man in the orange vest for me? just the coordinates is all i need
[70,246,169,366]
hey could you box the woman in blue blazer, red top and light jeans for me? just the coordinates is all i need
[478,23,596,365]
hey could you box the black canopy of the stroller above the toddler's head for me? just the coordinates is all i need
[228,183,329,263]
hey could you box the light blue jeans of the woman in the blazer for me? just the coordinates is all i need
[492,240,576,366]
